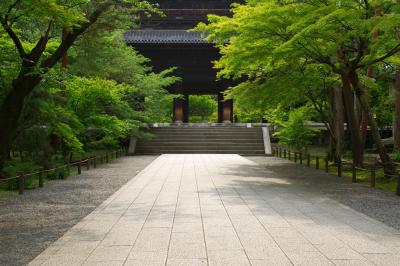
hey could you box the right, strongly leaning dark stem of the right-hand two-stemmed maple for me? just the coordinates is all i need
[350,72,396,176]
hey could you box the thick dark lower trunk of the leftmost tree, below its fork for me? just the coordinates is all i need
[0,67,41,170]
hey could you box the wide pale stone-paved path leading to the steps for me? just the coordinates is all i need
[31,155,400,266]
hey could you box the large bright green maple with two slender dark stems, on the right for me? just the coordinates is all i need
[197,0,400,174]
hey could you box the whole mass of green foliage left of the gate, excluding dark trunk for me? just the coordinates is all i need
[0,0,179,179]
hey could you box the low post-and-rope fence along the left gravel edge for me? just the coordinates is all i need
[0,149,128,195]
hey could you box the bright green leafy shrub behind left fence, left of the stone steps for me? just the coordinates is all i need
[67,77,139,149]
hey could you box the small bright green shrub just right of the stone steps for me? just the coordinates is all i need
[274,108,318,150]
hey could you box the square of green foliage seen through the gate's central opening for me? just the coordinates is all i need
[189,95,218,123]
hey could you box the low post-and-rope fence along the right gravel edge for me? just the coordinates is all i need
[272,144,400,196]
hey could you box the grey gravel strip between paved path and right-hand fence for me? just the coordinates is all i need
[246,157,400,230]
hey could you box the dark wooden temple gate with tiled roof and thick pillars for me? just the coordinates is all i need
[125,0,238,123]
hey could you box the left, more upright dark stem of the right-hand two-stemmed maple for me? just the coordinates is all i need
[341,73,364,166]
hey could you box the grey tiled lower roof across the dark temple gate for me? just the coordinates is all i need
[125,30,209,44]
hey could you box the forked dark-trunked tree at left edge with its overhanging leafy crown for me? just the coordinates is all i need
[0,0,154,169]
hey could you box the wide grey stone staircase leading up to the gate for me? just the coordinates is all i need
[135,127,265,155]
